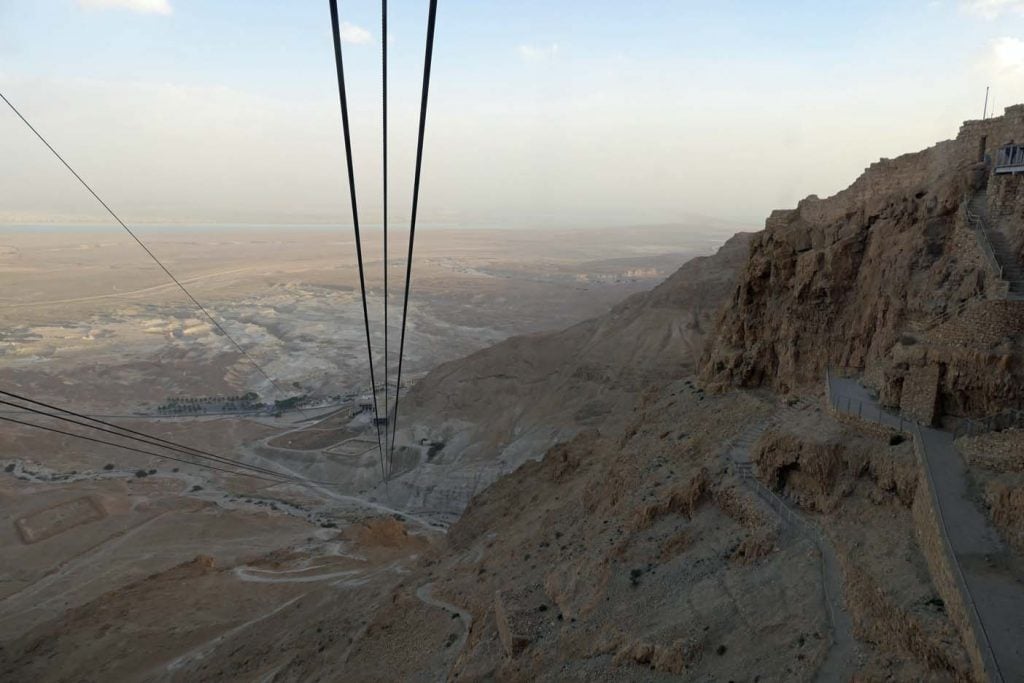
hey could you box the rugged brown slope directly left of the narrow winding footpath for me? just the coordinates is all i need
[407,382,828,681]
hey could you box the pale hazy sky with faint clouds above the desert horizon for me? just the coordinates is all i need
[0,0,1024,225]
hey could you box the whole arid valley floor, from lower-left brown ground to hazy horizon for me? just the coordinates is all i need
[0,226,737,680]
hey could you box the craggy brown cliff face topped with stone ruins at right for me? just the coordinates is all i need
[701,106,1024,421]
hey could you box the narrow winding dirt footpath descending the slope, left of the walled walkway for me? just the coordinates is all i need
[726,411,857,683]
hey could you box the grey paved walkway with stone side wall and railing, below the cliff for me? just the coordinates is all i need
[828,377,1024,683]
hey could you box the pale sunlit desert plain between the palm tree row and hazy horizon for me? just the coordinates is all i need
[0,227,729,413]
